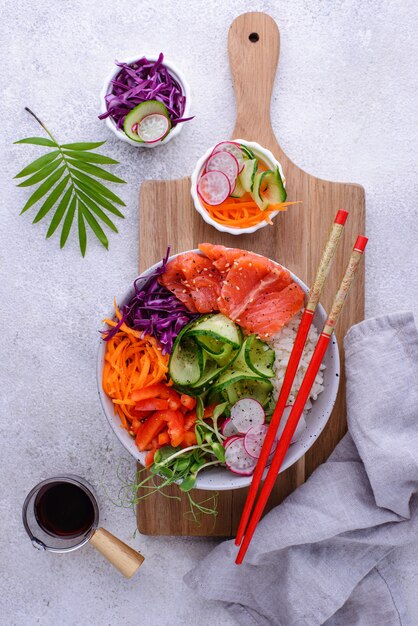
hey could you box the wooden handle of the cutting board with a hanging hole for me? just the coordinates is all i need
[228,13,280,152]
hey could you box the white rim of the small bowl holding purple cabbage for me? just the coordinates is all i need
[100,54,190,148]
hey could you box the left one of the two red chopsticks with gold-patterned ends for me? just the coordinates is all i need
[235,209,348,546]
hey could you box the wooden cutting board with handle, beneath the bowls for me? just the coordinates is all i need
[138,13,365,537]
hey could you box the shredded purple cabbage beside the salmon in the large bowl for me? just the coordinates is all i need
[102,248,199,354]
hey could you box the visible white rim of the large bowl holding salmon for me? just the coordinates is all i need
[97,250,340,491]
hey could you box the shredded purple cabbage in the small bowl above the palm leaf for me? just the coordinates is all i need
[99,52,193,128]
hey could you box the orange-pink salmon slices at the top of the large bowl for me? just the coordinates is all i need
[160,243,305,338]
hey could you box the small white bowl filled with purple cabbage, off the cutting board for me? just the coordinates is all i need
[99,52,192,148]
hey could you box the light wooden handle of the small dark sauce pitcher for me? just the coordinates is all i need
[90,528,144,578]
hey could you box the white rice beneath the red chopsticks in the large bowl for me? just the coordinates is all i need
[267,313,325,415]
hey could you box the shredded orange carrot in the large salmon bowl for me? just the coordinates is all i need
[102,326,169,424]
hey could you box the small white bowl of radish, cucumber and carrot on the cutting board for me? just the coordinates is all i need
[191,139,293,235]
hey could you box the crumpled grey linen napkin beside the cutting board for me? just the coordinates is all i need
[185,313,418,626]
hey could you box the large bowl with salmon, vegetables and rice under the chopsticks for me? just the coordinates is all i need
[97,244,340,491]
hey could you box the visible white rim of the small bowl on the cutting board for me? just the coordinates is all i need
[190,139,286,235]
